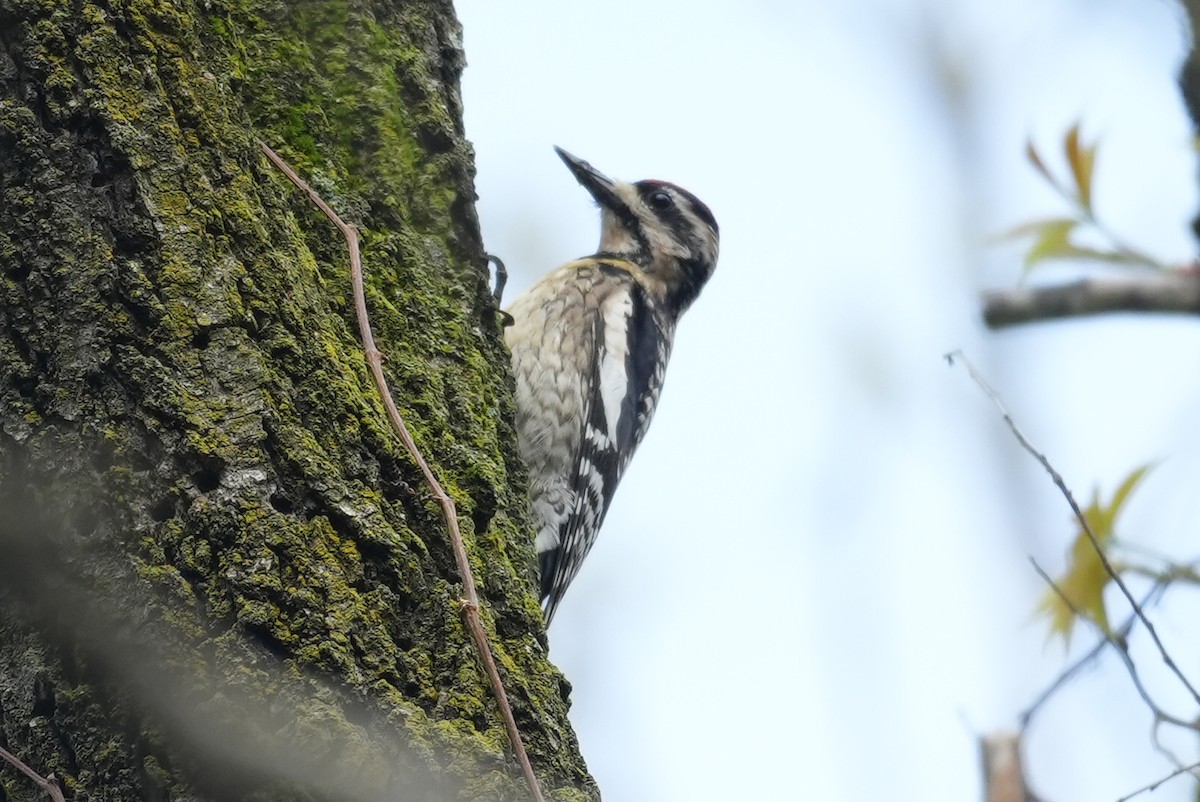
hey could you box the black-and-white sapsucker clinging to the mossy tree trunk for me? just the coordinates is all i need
[505,148,718,624]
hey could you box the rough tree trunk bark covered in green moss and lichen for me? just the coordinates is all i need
[0,0,598,801]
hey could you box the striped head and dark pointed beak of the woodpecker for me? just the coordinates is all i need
[554,148,719,315]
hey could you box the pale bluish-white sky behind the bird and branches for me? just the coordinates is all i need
[457,0,1200,802]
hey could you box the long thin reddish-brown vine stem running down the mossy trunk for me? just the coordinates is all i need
[258,140,544,802]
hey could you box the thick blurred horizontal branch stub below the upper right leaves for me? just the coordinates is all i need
[983,270,1200,329]
